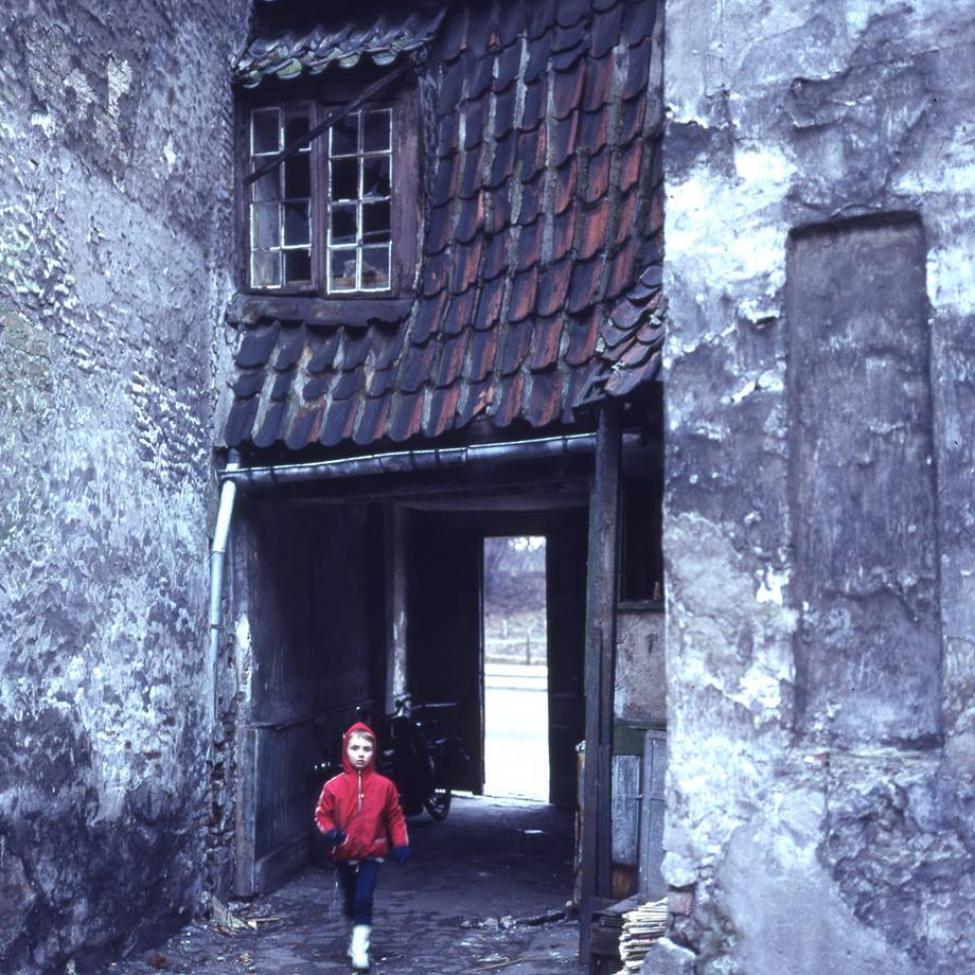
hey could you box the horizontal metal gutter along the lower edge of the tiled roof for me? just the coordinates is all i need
[220,433,639,487]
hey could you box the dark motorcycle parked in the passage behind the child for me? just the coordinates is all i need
[315,694,470,821]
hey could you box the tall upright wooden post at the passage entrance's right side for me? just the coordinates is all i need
[580,403,621,971]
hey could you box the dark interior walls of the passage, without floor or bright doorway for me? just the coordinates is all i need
[233,491,587,905]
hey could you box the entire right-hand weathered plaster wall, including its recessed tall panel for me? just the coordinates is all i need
[660,0,975,975]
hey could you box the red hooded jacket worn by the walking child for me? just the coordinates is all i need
[315,721,410,860]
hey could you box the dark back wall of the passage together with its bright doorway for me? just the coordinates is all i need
[405,506,587,809]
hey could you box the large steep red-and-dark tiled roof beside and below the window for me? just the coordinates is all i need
[225,0,663,450]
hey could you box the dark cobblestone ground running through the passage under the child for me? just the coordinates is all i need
[107,799,583,975]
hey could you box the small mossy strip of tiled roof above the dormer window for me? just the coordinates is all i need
[235,10,443,88]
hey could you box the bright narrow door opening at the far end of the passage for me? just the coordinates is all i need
[483,535,550,802]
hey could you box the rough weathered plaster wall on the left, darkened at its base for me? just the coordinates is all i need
[0,0,248,975]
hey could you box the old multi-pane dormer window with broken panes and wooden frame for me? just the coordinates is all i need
[243,93,417,298]
